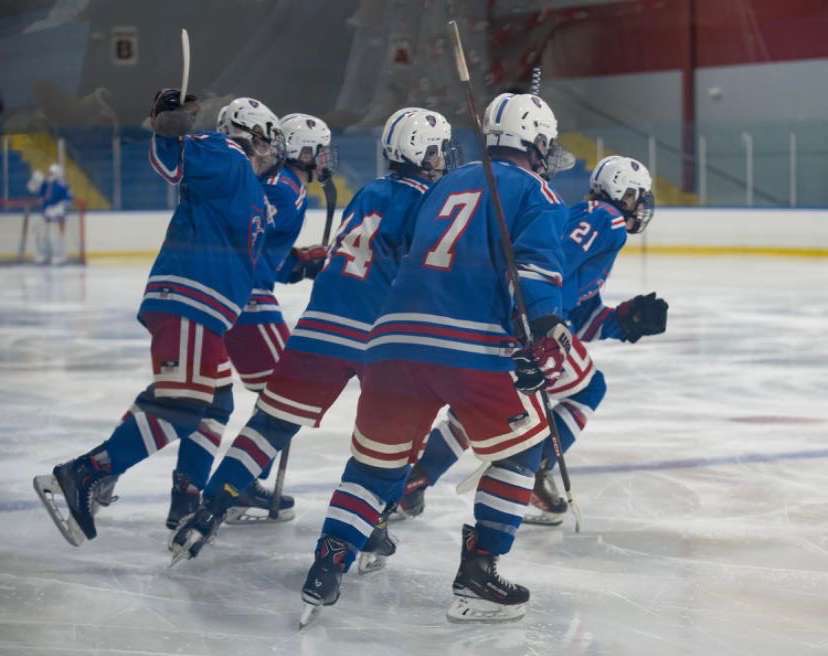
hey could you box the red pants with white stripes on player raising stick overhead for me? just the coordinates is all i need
[152,317,232,403]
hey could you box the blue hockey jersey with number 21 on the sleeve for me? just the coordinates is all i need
[563,200,627,342]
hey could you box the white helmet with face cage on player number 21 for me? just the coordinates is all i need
[589,155,655,233]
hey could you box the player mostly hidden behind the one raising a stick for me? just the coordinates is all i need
[167,106,334,530]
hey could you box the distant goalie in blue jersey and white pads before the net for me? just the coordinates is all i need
[26,162,72,264]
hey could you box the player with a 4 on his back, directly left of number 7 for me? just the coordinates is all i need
[171,108,451,561]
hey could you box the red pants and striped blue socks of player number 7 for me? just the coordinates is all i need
[322,361,547,559]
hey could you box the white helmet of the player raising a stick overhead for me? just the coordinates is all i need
[216,98,285,174]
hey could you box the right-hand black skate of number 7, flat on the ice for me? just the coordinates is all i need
[447,525,529,622]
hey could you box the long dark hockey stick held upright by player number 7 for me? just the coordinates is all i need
[449,20,581,533]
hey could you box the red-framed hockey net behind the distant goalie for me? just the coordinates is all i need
[0,198,86,264]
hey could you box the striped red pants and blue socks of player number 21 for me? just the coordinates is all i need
[419,339,607,485]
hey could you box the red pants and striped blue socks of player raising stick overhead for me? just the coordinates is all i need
[95,313,230,475]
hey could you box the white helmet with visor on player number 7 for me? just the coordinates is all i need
[483,93,575,176]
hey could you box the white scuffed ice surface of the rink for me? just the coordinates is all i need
[0,256,828,656]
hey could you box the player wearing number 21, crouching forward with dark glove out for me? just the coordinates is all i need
[395,155,667,526]
